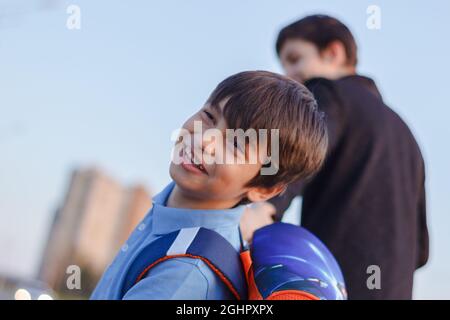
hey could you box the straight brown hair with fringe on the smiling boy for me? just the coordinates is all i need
[208,71,328,187]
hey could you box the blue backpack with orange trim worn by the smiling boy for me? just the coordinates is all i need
[121,223,347,300]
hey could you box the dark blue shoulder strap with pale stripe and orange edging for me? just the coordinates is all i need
[121,228,247,300]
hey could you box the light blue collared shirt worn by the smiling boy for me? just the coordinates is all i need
[91,182,245,300]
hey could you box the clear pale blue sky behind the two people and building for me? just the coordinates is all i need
[0,0,450,298]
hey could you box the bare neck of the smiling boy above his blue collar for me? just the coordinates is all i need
[166,185,238,210]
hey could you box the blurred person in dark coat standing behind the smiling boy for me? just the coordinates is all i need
[242,15,429,299]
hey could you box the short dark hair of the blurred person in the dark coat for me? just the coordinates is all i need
[275,15,358,66]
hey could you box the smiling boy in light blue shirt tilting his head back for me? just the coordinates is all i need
[91,71,328,299]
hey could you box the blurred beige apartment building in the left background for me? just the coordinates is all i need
[39,169,151,295]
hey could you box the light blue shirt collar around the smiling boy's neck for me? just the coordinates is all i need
[152,181,245,235]
